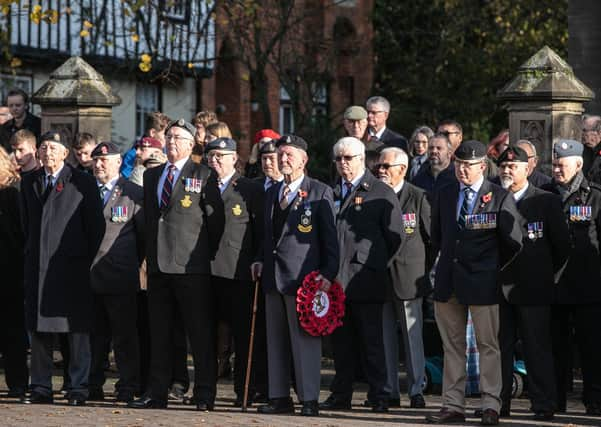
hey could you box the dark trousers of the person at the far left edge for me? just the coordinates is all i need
[0,286,29,391]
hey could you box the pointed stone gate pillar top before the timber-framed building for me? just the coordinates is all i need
[33,56,121,142]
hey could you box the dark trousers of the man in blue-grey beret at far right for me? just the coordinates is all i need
[551,303,601,410]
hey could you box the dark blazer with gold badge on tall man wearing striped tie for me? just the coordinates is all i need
[144,159,212,274]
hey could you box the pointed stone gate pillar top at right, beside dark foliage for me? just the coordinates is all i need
[497,46,595,174]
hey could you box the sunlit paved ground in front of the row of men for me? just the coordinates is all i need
[0,369,601,427]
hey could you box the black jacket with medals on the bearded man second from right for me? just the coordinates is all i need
[503,184,570,305]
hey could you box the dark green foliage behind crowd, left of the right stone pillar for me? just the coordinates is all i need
[374,0,568,141]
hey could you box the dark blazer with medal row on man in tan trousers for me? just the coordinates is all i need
[432,179,523,305]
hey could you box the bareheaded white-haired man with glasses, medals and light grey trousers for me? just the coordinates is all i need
[377,147,432,408]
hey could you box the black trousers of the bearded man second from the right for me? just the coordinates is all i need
[499,299,557,412]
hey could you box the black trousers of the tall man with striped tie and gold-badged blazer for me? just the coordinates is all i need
[147,273,217,403]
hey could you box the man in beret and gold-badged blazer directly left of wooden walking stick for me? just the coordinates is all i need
[205,138,264,406]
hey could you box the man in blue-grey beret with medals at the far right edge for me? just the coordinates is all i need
[543,139,601,416]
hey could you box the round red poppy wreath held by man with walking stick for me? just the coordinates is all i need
[296,271,345,337]
